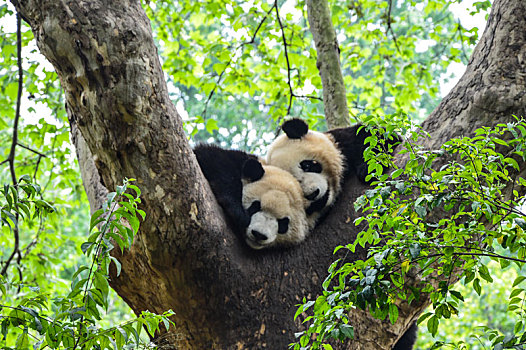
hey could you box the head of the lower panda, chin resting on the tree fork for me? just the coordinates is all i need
[242,159,309,249]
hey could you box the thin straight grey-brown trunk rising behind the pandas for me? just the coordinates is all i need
[307,0,349,129]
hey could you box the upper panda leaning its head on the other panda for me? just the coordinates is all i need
[267,118,398,225]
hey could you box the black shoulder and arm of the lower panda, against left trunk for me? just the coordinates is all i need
[194,144,257,237]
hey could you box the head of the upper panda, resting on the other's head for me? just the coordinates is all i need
[267,119,344,216]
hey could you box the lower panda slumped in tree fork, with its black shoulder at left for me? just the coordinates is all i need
[194,145,309,249]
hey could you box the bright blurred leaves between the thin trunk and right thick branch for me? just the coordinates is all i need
[332,0,478,120]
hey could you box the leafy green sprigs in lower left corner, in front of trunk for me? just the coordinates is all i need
[0,176,171,349]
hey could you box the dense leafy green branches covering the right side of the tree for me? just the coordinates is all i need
[294,120,526,349]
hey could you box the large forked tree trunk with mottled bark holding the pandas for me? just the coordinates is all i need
[12,0,526,349]
